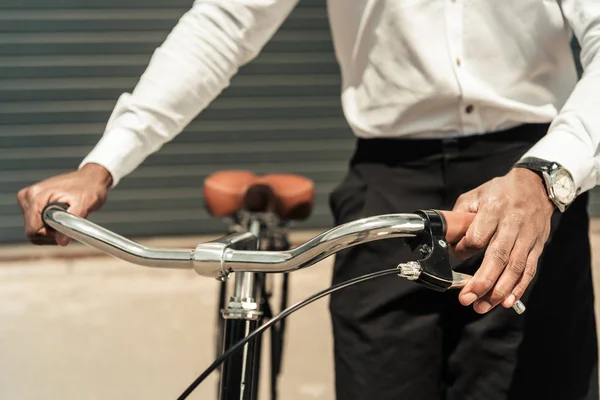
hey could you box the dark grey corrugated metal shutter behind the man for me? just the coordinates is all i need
[0,0,353,242]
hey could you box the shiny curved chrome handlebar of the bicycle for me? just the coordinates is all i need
[42,205,425,279]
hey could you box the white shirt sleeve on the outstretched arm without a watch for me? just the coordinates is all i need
[80,0,298,187]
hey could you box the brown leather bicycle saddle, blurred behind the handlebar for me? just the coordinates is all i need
[204,171,315,221]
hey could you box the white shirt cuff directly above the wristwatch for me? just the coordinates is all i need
[523,131,598,193]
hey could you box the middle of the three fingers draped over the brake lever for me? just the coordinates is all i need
[473,235,536,313]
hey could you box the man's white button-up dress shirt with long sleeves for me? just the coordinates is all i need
[82,0,600,191]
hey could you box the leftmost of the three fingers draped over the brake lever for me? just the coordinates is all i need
[459,229,517,313]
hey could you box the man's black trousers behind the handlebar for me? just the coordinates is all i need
[330,125,598,400]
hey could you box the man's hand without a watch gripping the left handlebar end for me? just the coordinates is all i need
[17,164,112,246]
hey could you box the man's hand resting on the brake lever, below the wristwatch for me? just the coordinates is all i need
[454,168,555,314]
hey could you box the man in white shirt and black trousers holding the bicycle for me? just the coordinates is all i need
[14,0,600,400]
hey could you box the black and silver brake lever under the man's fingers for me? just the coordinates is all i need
[398,210,525,314]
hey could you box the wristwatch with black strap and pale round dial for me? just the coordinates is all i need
[515,157,578,212]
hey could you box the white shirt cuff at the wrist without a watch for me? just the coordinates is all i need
[79,129,144,188]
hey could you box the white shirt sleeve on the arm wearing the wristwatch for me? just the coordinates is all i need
[525,0,600,192]
